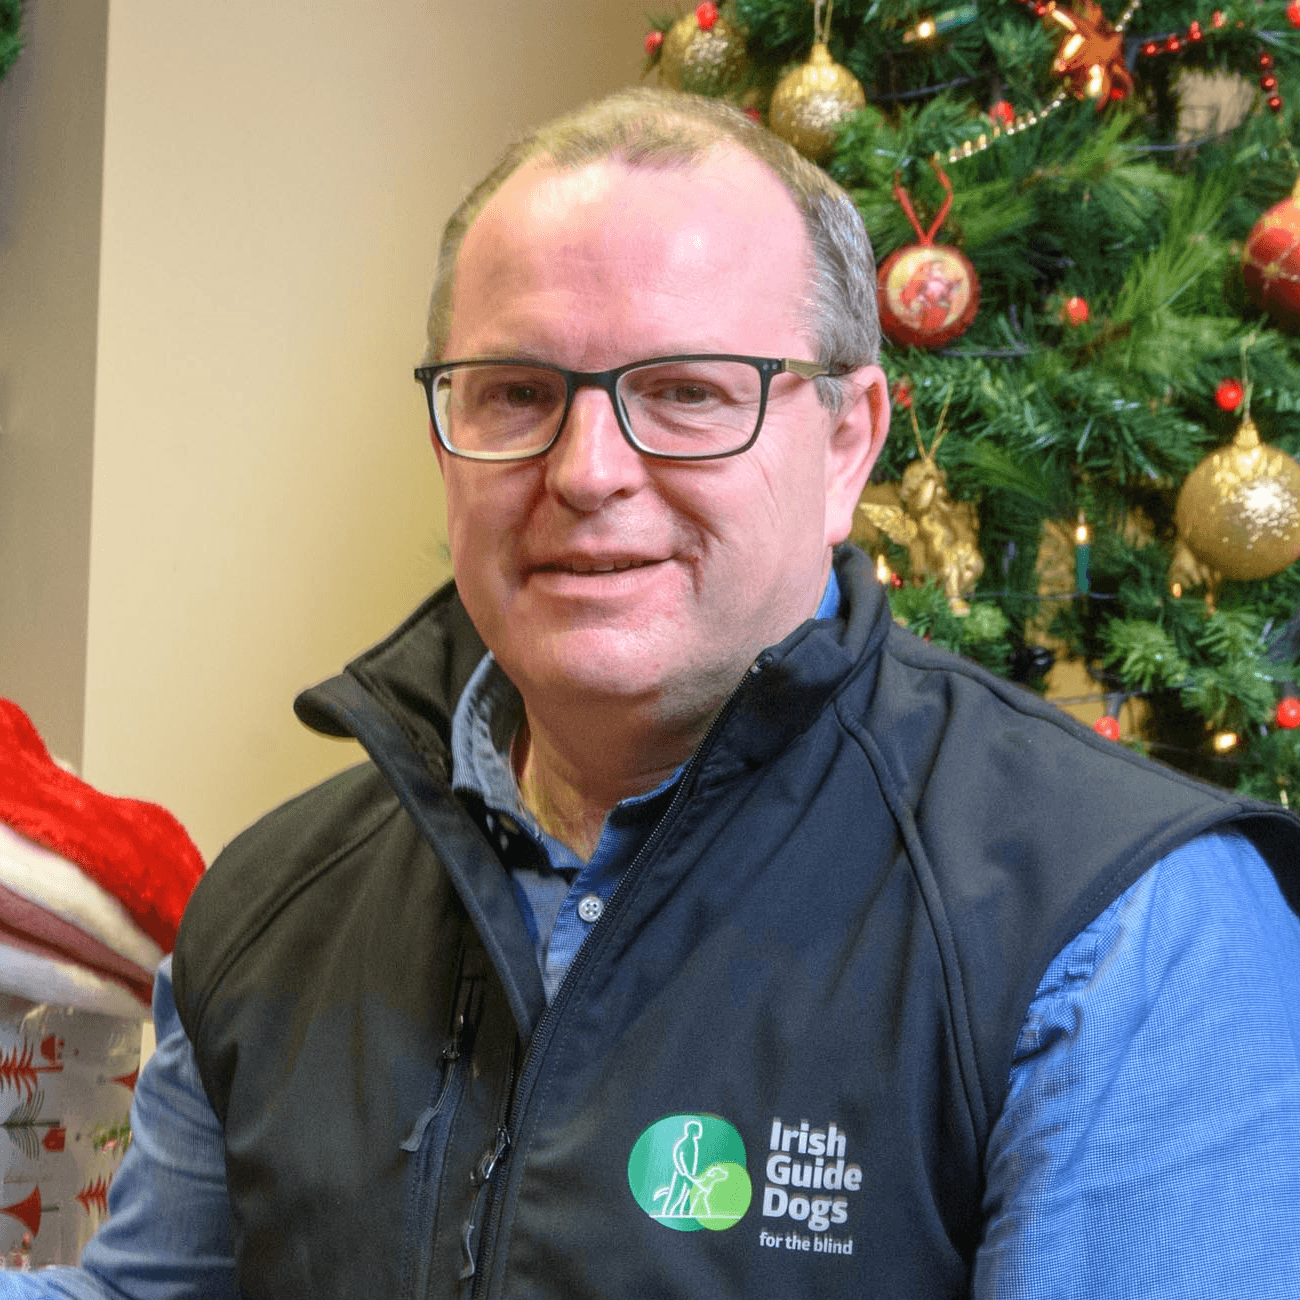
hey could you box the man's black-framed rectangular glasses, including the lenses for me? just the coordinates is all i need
[415,354,833,460]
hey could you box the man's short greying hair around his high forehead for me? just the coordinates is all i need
[425,90,880,408]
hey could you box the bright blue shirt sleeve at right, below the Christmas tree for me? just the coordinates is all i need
[972,835,1300,1300]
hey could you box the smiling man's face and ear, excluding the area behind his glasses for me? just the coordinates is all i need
[438,152,887,725]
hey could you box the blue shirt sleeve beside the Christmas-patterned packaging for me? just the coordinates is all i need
[0,957,239,1300]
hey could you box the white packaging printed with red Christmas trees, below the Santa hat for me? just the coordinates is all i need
[0,993,142,1269]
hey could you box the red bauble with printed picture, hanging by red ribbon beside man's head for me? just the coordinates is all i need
[876,163,979,347]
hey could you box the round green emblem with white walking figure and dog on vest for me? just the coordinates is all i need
[628,1115,754,1232]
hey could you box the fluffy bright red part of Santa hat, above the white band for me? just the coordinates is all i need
[0,699,203,953]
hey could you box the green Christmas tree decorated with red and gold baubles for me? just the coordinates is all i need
[646,0,1300,802]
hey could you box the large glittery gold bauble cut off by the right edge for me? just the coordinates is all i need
[1174,417,1300,581]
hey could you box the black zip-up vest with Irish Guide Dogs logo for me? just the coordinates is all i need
[176,551,1300,1300]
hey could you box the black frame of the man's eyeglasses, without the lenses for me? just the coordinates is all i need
[415,352,844,462]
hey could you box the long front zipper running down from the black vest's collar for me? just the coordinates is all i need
[462,651,770,1300]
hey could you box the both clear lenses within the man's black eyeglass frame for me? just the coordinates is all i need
[433,360,763,456]
